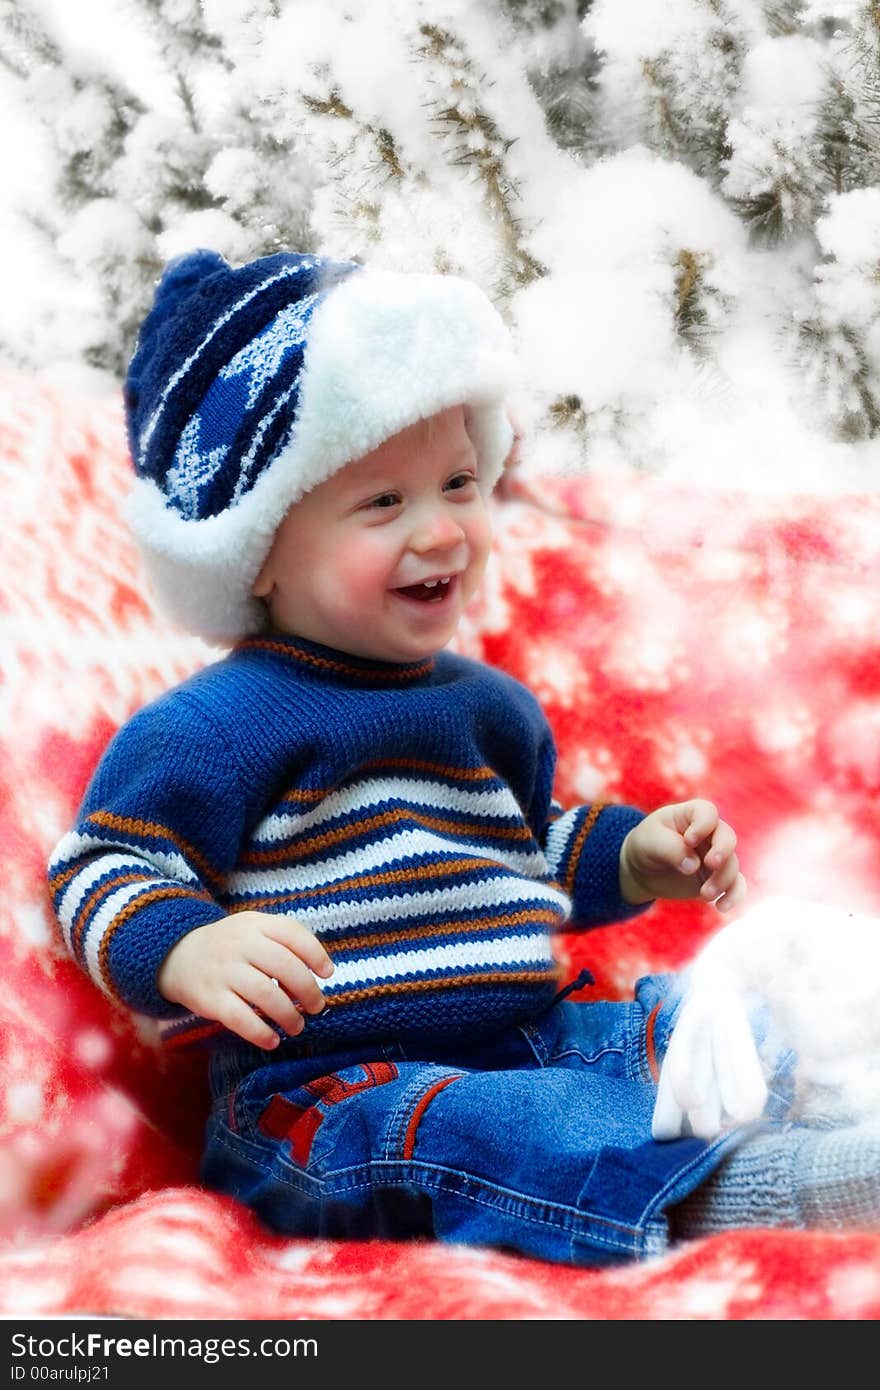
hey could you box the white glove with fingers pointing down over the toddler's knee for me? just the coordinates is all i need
[651,979,767,1140]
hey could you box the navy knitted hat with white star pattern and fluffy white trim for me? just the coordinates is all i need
[125,250,513,641]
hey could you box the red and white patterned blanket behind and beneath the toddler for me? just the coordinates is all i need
[0,374,880,1319]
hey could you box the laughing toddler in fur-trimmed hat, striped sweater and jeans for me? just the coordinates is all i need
[50,252,876,1264]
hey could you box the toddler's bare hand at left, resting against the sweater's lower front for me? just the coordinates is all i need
[156,912,334,1048]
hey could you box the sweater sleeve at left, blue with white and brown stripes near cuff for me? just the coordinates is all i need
[49,691,245,1017]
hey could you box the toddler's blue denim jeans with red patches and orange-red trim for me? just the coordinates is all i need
[202,976,795,1265]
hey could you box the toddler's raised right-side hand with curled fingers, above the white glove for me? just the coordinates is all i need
[620,801,747,912]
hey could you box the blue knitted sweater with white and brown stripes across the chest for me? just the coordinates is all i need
[50,637,641,1047]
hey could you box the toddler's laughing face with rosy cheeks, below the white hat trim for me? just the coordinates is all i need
[253,406,491,662]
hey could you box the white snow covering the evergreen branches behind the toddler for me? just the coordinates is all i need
[0,0,880,491]
